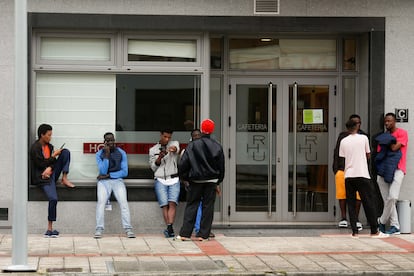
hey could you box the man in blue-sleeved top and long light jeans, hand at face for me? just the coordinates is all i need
[94,132,135,239]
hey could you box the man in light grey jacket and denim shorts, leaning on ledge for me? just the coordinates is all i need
[149,129,180,238]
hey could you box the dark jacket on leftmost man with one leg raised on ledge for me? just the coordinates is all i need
[30,140,56,185]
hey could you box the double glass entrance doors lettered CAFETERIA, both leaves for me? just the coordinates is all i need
[228,78,334,222]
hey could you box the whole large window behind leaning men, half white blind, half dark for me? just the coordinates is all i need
[32,73,200,182]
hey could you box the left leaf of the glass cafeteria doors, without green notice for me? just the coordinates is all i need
[229,79,280,221]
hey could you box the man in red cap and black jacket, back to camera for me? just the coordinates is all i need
[177,119,224,241]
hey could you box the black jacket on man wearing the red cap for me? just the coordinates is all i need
[178,135,224,184]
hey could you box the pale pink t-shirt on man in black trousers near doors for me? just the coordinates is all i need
[339,134,371,179]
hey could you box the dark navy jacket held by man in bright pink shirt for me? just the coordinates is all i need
[375,132,402,183]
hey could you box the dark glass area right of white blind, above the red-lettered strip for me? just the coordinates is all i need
[116,75,199,131]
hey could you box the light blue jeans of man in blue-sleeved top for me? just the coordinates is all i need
[96,178,132,230]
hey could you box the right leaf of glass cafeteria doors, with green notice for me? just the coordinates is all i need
[287,78,335,222]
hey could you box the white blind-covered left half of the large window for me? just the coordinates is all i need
[32,73,115,181]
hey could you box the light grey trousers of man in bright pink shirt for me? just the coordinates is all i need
[377,170,404,229]
